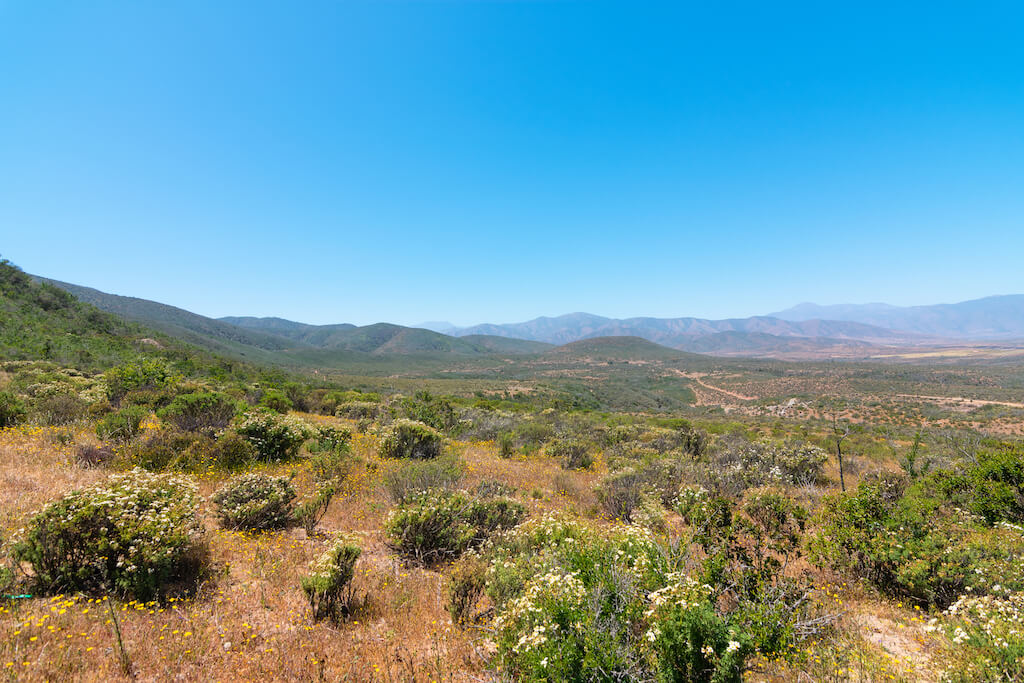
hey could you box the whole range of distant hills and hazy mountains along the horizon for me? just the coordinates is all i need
[38,278,1024,362]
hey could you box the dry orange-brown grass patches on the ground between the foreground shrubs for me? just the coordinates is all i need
[0,416,958,681]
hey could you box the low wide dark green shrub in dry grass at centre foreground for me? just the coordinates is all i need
[384,492,526,565]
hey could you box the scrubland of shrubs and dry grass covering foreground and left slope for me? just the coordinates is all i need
[0,259,1024,682]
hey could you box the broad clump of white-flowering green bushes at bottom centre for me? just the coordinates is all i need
[471,515,770,682]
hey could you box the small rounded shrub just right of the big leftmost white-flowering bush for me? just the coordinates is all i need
[211,474,295,531]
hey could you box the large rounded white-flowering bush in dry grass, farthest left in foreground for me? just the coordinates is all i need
[13,469,206,600]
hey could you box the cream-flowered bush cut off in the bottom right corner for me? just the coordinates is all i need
[930,593,1024,683]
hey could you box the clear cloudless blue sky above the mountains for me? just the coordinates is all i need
[0,0,1024,324]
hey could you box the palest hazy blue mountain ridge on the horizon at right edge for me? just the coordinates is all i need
[772,294,1024,340]
